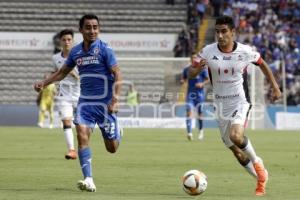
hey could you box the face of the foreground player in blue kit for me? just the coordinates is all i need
[79,19,99,43]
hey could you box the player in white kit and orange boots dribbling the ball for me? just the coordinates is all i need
[189,16,281,196]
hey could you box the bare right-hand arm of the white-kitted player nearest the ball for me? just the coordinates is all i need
[259,59,281,101]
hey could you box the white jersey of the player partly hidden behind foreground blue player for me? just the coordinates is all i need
[52,52,80,102]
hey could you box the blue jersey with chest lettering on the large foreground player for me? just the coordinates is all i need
[65,39,117,103]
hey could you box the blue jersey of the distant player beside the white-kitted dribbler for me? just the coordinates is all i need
[182,66,208,101]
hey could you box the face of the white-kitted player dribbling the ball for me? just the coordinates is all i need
[215,24,235,47]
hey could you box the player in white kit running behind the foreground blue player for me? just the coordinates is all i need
[52,29,80,160]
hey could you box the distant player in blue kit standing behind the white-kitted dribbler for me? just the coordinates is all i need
[181,55,209,140]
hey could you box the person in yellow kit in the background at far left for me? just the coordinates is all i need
[37,74,56,128]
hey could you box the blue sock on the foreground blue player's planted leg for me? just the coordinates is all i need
[78,147,92,178]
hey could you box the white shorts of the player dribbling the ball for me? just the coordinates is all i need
[217,103,251,148]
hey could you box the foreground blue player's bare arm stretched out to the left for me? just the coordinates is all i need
[34,64,72,92]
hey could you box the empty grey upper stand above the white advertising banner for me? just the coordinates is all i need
[0,0,187,33]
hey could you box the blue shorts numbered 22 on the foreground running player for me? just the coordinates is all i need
[74,102,120,141]
